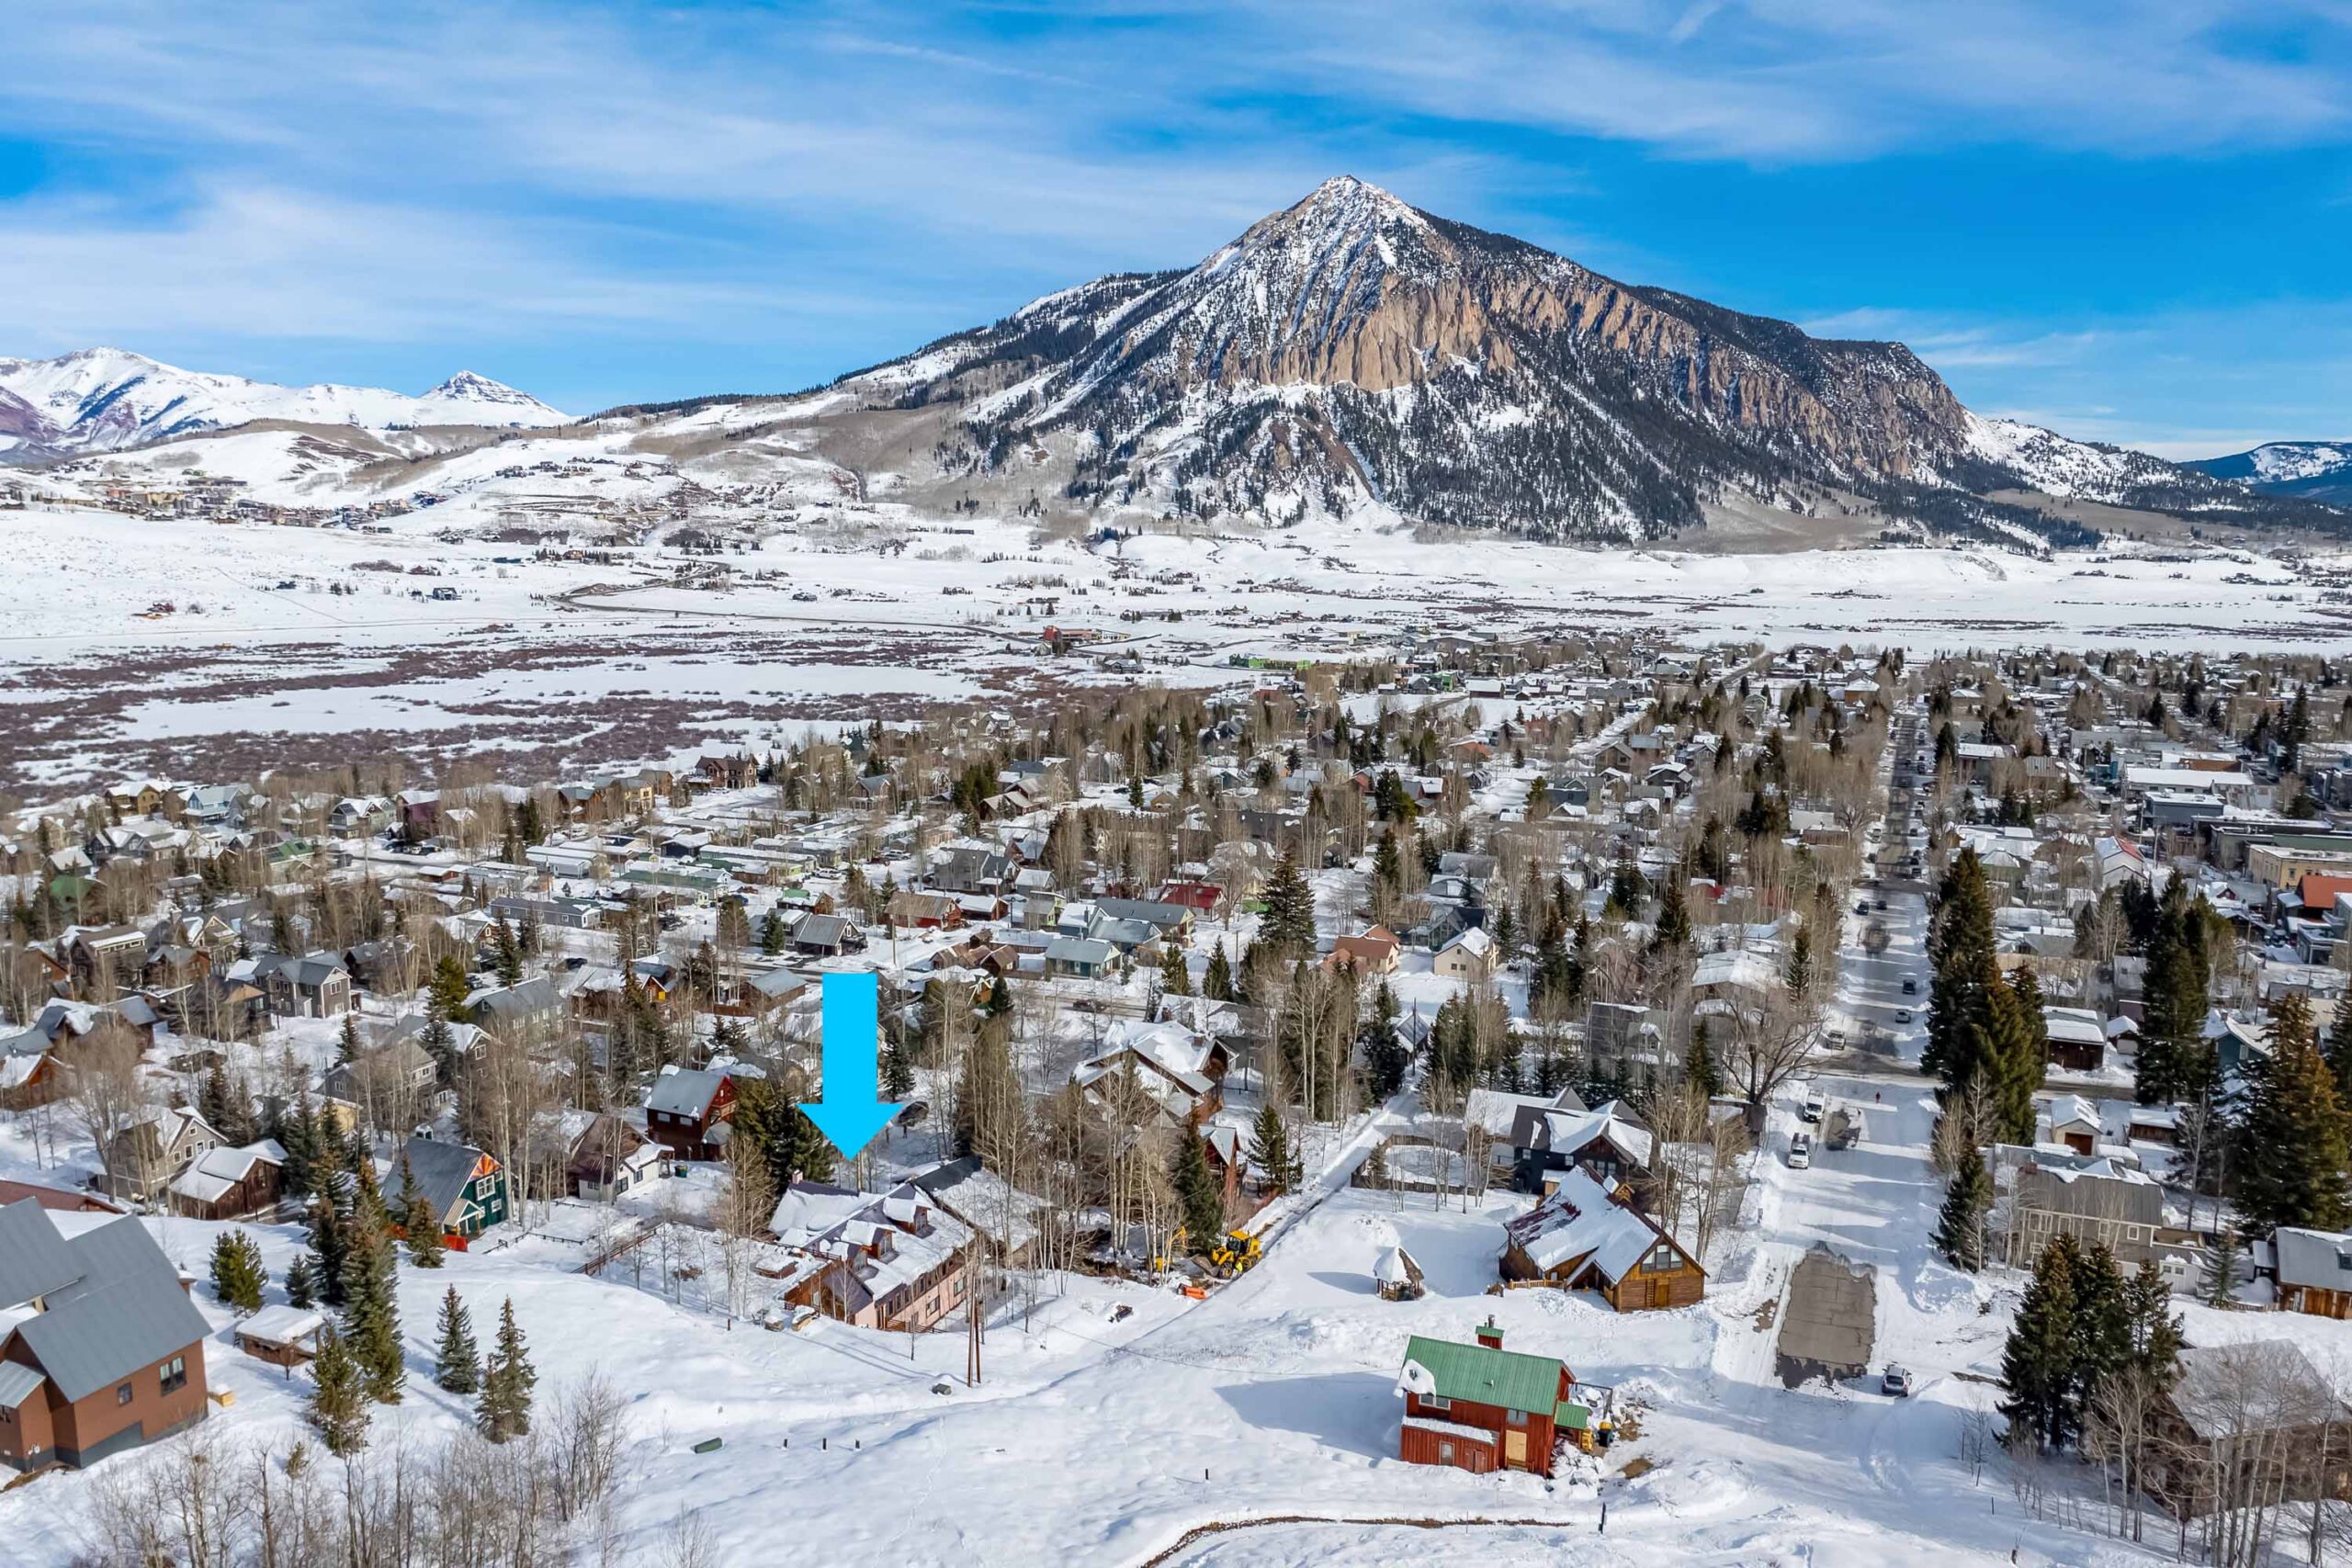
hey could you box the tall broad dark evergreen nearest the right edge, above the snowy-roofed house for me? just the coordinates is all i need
[2237,992,2352,1235]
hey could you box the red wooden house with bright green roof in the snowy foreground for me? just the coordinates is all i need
[1397,1319,1590,1476]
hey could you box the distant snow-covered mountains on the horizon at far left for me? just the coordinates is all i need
[0,348,570,461]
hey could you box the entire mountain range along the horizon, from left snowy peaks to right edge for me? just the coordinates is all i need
[0,176,2352,546]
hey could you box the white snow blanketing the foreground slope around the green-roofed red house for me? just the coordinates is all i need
[0,1066,2277,1568]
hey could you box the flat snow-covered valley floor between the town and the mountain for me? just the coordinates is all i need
[0,501,2352,787]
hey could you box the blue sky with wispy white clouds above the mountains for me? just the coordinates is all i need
[0,0,2352,456]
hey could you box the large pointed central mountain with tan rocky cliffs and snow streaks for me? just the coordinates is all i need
[852,176,2324,538]
